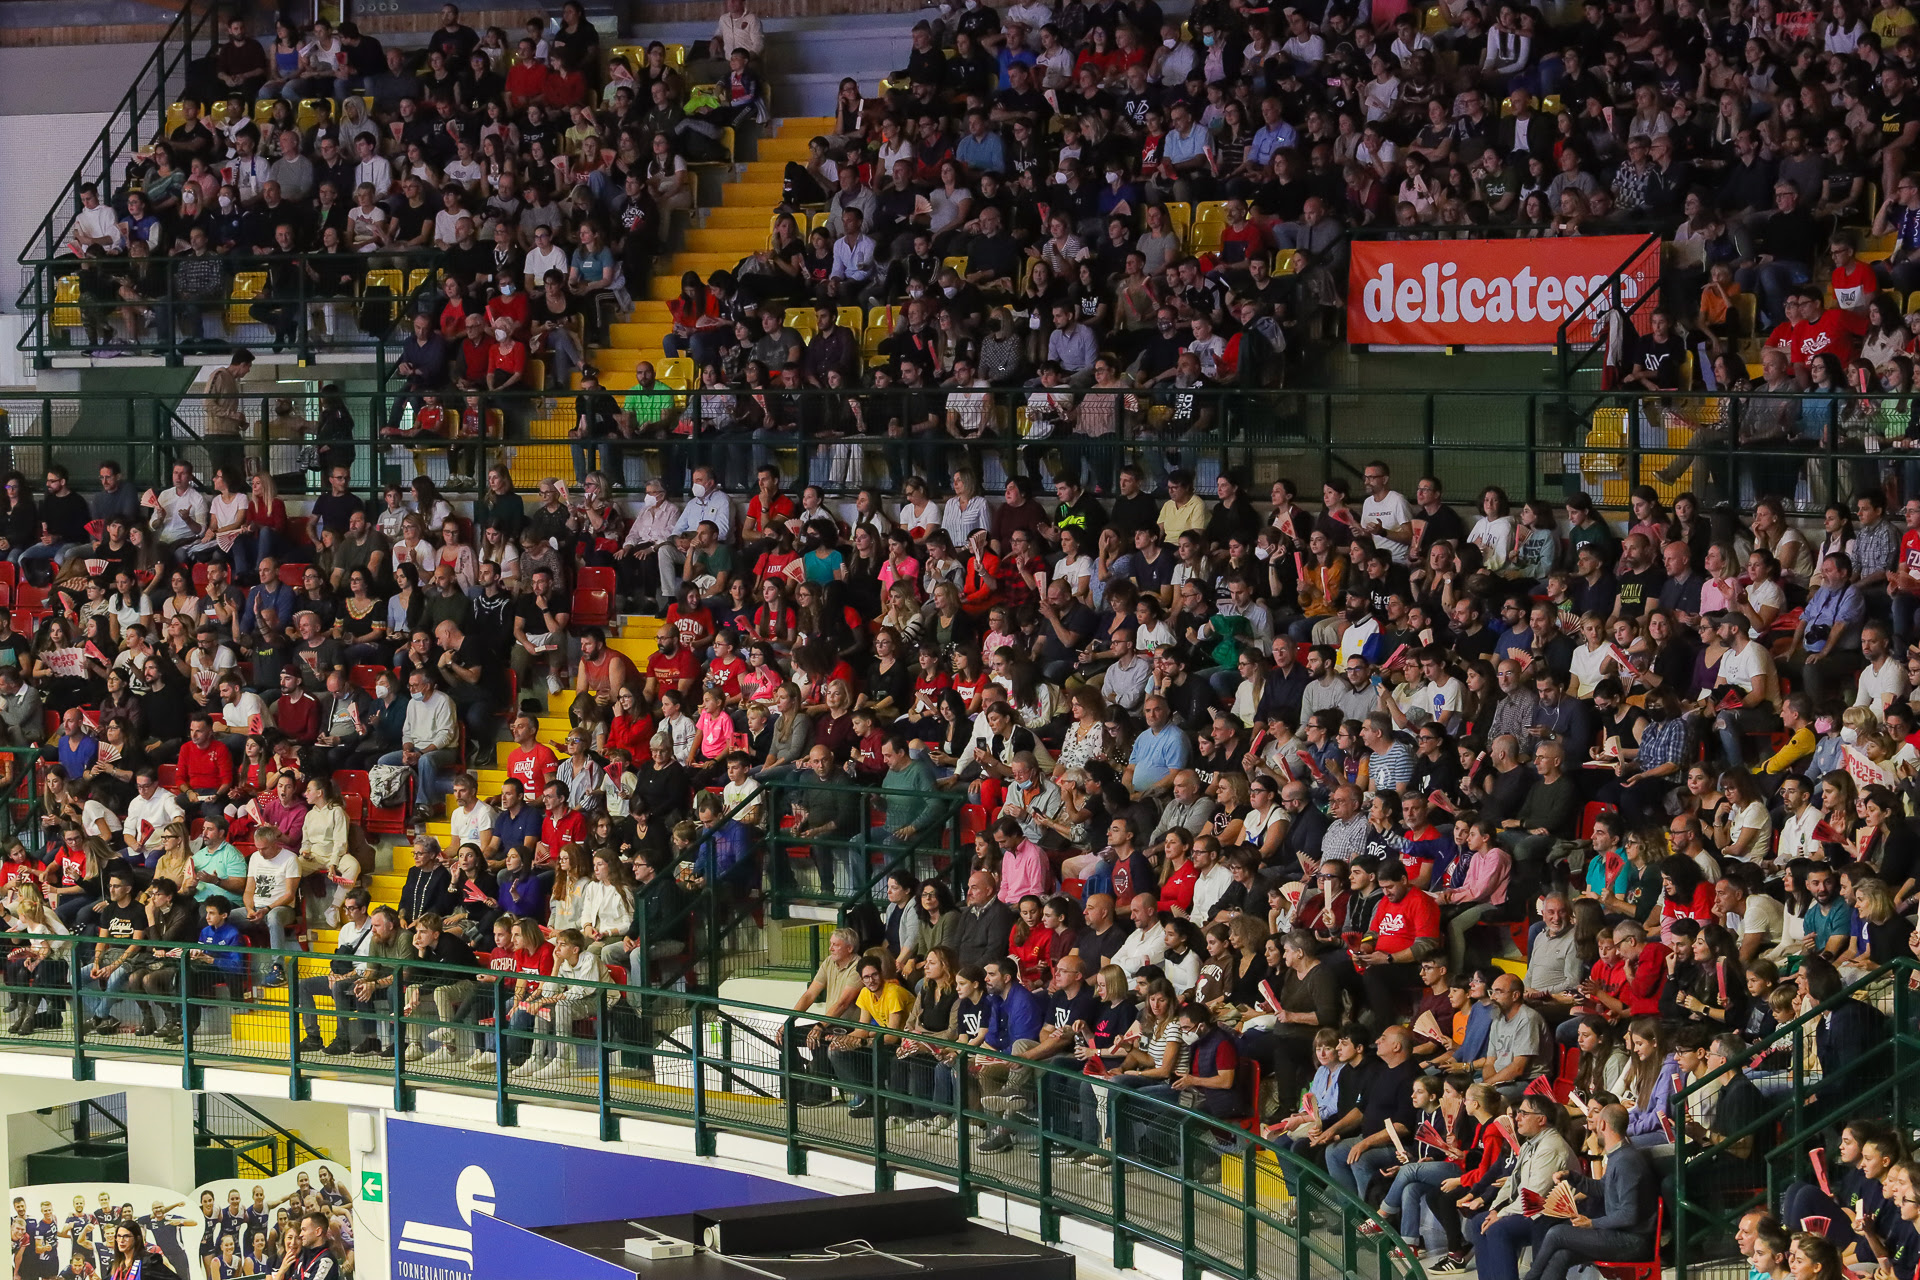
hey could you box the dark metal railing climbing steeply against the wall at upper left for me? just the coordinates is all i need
[15,0,221,351]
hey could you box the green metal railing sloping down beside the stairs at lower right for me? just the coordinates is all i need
[1670,956,1920,1274]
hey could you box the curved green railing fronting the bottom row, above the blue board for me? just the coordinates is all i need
[0,935,1421,1280]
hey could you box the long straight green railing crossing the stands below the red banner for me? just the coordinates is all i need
[0,383,1920,512]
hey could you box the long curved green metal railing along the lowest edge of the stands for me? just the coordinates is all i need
[0,935,1423,1280]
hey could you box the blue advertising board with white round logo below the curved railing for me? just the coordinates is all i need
[386,1117,820,1280]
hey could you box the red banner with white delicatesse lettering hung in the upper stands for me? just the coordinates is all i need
[1346,236,1659,347]
